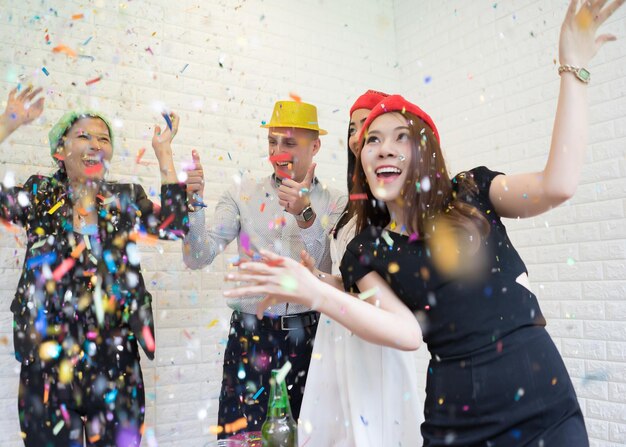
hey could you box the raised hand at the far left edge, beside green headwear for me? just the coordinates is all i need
[0,86,45,142]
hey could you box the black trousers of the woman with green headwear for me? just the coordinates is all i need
[18,339,145,447]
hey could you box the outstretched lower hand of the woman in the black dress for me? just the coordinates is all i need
[224,250,322,318]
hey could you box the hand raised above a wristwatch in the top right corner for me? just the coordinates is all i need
[559,0,626,67]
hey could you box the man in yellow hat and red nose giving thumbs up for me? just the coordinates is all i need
[183,101,346,438]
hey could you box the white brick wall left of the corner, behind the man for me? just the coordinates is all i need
[0,0,398,447]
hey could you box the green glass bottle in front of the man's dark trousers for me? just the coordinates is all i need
[261,369,298,447]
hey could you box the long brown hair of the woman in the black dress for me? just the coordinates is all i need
[350,112,489,246]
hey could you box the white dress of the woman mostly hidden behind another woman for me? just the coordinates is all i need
[298,217,424,447]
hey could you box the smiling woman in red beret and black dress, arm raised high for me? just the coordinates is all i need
[225,0,624,447]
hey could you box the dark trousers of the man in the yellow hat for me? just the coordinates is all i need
[218,313,318,439]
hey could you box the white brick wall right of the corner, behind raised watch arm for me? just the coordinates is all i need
[394,0,626,447]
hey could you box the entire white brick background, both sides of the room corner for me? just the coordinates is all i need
[0,0,626,447]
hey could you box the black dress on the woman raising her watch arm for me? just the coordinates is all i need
[341,167,589,447]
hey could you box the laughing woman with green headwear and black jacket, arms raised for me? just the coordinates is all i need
[0,87,188,447]
